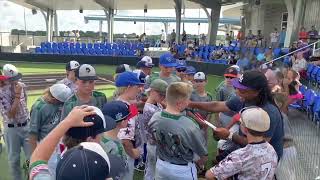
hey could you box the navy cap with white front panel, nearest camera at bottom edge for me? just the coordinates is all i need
[56,142,125,180]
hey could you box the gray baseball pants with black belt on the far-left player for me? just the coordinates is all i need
[4,124,31,180]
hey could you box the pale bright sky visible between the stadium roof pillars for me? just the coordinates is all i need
[0,0,235,35]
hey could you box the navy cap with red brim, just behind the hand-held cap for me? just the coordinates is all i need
[102,101,130,122]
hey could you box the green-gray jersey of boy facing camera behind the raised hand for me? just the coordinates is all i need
[61,91,107,119]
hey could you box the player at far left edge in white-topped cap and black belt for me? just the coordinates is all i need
[0,64,31,180]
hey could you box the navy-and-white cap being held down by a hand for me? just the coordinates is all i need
[66,106,116,139]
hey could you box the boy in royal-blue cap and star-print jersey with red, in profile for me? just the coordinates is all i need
[115,72,144,179]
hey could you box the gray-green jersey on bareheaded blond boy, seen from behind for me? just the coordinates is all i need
[148,111,208,164]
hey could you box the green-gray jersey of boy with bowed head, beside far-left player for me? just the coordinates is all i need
[29,97,63,141]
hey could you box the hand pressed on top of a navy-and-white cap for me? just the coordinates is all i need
[65,105,95,127]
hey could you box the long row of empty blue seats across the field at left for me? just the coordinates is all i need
[35,42,144,56]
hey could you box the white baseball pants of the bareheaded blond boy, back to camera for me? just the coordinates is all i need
[155,158,198,180]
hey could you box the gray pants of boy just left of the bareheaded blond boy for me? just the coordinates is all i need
[144,143,157,180]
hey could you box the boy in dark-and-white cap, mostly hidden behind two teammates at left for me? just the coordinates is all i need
[58,61,80,93]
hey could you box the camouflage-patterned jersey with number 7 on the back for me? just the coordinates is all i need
[210,142,278,180]
